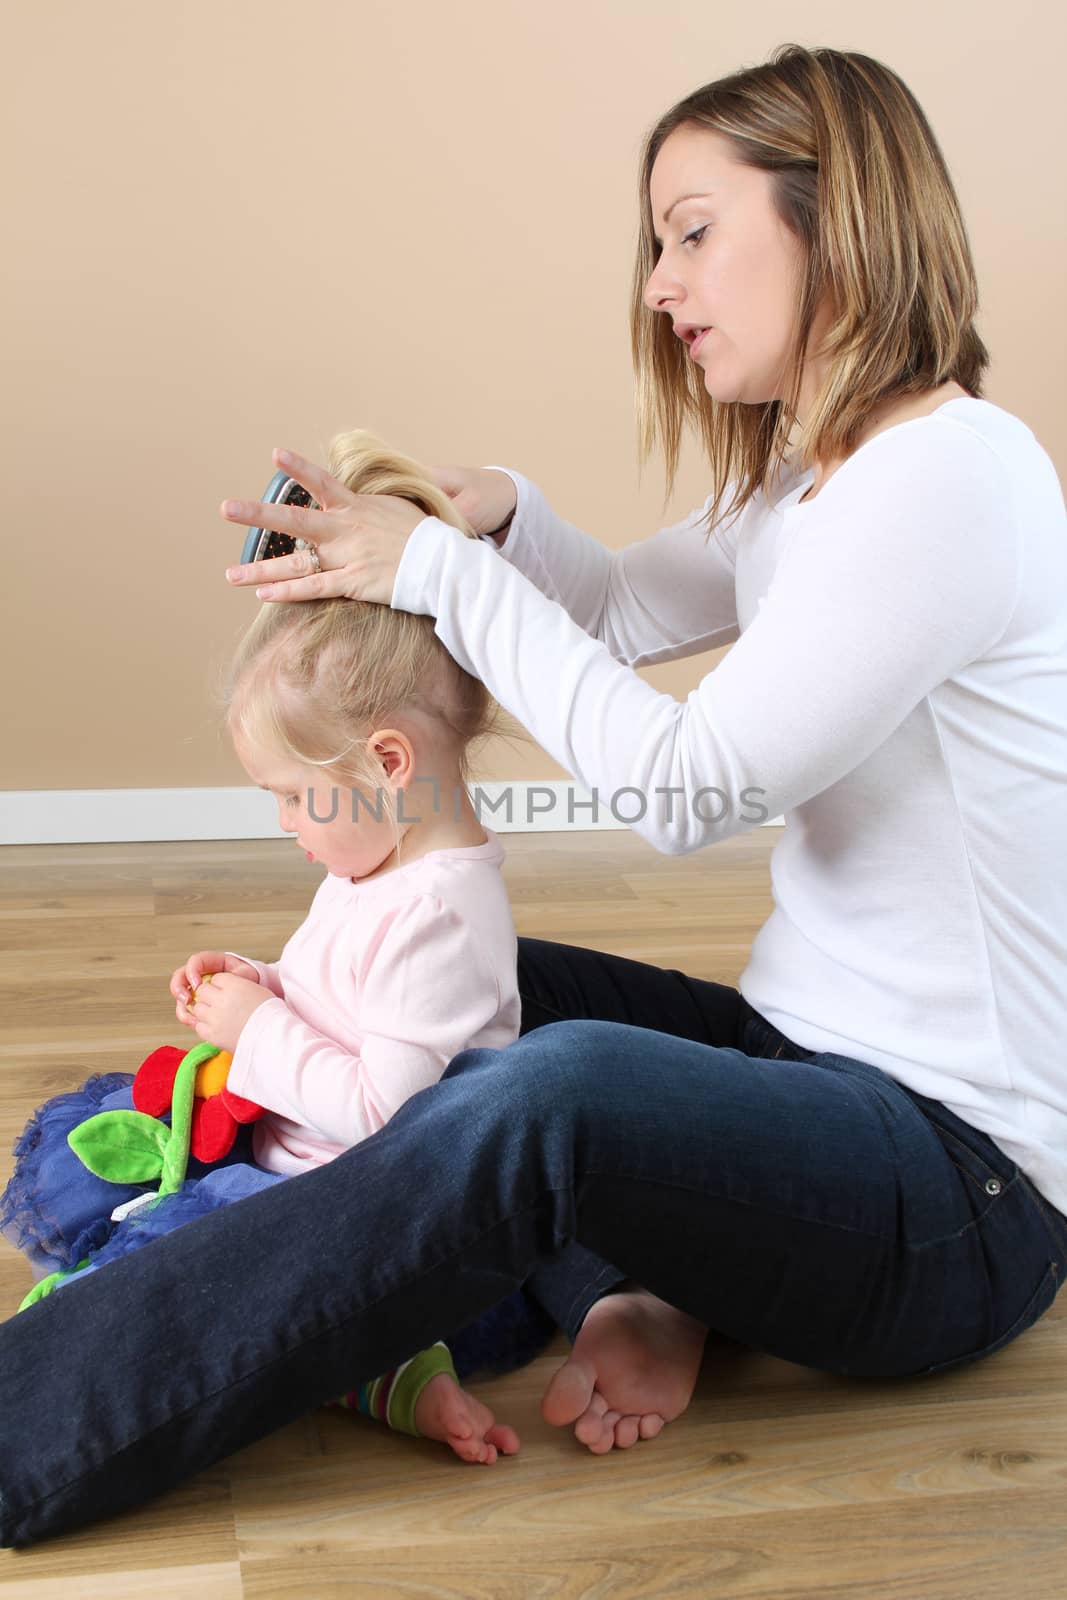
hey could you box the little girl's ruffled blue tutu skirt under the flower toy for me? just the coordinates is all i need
[0,1072,555,1378]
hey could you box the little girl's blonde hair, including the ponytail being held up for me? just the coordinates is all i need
[222,429,514,851]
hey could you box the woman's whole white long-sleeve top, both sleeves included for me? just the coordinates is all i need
[392,398,1067,1211]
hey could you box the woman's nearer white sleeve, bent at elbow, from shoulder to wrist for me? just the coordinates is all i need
[390,421,1019,854]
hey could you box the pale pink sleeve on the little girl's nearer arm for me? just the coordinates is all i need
[229,894,501,1146]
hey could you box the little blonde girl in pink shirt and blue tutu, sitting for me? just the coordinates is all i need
[0,432,552,1462]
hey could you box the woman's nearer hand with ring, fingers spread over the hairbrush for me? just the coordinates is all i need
[221,450,427,605]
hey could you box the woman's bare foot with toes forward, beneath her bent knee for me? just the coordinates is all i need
[541,1285,707,1456]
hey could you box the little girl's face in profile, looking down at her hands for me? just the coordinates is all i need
[234,736,397,883]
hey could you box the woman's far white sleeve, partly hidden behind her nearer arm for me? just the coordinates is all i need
[483,467,737,667]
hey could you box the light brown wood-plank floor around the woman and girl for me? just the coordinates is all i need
[0,827,1067,1600]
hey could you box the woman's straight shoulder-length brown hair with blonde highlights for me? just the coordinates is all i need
[630,45,989,531]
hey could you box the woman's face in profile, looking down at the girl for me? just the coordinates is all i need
[645,126,824,416]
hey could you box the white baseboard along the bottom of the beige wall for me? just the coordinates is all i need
[0,779,782,845]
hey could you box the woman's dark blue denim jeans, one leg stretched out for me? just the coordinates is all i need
[0,939,1067,1544]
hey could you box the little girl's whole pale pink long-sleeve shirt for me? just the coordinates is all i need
[229,827,520,1173]
